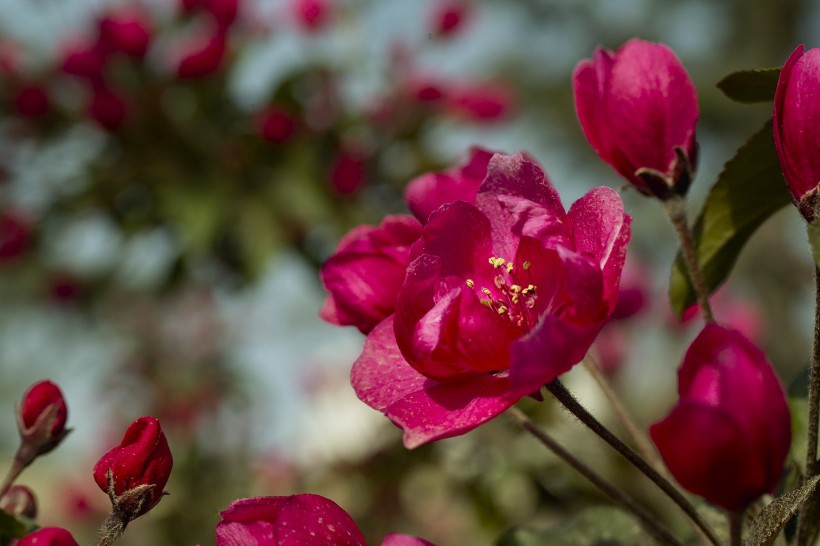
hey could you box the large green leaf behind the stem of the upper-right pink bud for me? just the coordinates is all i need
[669,121,791,316]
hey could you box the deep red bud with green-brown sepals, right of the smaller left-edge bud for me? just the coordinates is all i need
[94,417,174,523]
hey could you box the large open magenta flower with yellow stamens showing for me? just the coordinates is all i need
[351,154,630,448]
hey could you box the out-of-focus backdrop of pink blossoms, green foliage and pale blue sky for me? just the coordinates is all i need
[0,0,820,546]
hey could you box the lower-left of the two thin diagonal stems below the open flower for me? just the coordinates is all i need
[508,407,682,546]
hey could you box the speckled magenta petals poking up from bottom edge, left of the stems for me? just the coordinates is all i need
[216,493,433,546]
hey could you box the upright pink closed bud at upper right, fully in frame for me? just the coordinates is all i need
[572,39,698,197]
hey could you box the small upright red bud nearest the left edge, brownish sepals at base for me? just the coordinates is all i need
[17,381,70,464]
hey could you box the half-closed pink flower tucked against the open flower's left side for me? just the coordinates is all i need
[320,216,421,334]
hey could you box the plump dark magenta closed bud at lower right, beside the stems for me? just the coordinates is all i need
[649,324,791,510]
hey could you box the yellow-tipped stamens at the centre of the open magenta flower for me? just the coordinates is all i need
[465,256,538,331]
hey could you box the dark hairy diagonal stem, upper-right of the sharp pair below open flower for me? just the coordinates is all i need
[546,379,720,546]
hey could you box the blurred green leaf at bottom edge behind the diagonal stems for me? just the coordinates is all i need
[496,506,655,546]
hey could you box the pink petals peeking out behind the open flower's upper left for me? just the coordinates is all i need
[404,147,493,222]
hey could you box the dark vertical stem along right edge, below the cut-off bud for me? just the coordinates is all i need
[796,267,820,546]
